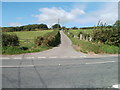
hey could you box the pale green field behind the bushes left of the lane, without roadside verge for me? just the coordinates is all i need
[7,30,53,48]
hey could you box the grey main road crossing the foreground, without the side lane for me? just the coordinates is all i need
[2,57,118,88]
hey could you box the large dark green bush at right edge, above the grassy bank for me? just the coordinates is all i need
[92,21,120,46]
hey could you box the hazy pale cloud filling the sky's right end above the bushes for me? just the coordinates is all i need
[76,3,118,25]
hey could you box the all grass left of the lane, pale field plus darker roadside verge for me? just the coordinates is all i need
[2,30,53,54]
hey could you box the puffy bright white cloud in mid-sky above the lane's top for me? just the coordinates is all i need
[33,7,85,25]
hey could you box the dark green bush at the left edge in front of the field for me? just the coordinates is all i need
[2,33,19,46]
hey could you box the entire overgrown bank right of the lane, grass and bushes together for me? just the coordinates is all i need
[65,21,120,54]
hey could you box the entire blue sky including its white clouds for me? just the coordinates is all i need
[2,2,118,27]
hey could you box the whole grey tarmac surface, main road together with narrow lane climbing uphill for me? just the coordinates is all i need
[1,32,118,88]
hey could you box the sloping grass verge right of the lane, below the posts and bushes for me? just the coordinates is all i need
[66,30,120,54]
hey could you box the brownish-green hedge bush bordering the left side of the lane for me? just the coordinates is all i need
[35,30,60,46]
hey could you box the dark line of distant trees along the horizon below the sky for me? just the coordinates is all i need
[2,20,120,32]
